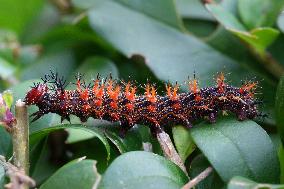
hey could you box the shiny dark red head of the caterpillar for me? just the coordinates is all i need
[25,83,48,105]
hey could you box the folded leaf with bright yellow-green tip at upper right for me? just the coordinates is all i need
[206,4,279,53]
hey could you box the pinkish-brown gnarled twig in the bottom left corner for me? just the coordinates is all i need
[0,156,36,189]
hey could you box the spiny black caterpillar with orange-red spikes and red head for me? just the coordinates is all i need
[25,72,259,135]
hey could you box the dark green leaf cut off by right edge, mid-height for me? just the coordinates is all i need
[275,76,284,144]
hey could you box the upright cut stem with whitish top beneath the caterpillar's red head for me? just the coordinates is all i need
[11,100,29,188]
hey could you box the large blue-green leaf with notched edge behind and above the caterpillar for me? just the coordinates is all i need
[88,1,255,89]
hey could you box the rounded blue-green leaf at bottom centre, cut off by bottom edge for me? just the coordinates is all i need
[99,151,188,189]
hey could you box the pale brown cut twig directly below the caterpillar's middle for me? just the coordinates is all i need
[157,131,188,176]
